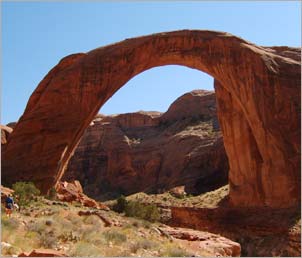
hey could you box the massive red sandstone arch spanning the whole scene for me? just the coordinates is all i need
[2,30,301,207]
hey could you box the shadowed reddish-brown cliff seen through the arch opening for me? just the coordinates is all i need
[62,90,229,197]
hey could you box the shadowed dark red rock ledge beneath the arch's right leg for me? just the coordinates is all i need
[170,203,301,257]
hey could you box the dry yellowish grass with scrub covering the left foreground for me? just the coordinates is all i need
[2,195,197,256]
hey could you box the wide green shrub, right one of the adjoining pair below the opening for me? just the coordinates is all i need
[125,201,160,222]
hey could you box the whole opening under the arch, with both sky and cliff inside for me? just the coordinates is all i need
[62,65,228,201]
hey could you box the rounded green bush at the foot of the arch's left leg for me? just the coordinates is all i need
[12,182,40,206]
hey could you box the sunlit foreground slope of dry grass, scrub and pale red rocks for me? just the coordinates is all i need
[1,190,241,257]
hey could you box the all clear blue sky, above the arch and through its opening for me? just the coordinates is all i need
[1,1,301,124]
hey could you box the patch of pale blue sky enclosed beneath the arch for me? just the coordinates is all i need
[99,65,214,115]
